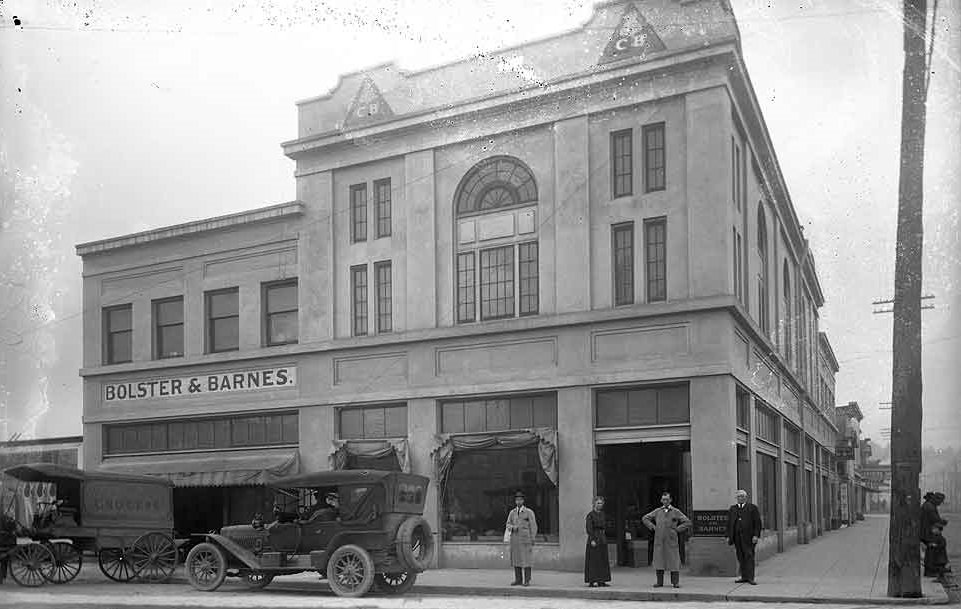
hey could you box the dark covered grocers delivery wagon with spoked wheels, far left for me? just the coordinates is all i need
[0,463,177,586]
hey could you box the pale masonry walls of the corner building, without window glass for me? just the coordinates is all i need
[77,0,836,575]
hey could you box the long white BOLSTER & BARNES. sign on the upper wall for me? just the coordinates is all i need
[103,366,297,402]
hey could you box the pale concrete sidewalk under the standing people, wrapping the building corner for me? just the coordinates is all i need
[65,516,948,605]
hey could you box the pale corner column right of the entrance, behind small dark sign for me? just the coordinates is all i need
[687,376,737,576]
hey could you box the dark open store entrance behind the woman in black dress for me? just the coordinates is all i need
[595,440,691,567]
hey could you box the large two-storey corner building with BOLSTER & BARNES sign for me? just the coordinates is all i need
[78,0,836,575]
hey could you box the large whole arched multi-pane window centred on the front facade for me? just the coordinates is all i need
[454,156,540,323]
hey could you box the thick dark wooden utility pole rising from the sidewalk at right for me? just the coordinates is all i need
[888,0,928,598]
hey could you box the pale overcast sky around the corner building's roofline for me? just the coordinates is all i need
[0,0,961,446]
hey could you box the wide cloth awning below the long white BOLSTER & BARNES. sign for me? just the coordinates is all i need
[99,451,300,487]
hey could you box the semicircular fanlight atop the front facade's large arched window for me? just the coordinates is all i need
[454,156,537,216]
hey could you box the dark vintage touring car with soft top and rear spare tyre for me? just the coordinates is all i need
[184,470,434,597]
